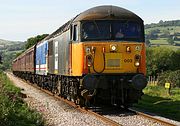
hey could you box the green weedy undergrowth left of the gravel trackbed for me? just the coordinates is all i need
[0,73,44,126]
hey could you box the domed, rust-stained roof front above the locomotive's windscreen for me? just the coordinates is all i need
[74,5,142,21]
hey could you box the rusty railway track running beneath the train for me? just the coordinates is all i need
[8,73,179,126]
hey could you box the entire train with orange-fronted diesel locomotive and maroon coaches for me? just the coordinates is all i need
[12,6,147,106]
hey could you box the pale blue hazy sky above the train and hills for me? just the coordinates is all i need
[0,0,180,41]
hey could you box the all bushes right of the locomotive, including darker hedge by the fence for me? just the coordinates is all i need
[146,47,180,87]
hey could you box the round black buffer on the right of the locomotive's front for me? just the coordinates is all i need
[132,74,147,90]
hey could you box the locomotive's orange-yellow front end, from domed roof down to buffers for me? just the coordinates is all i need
[72,6,147,104]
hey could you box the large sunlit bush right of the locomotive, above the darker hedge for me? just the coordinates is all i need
[146,47,180,76]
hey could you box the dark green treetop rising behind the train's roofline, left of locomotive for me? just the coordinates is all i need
[25,34,48,49]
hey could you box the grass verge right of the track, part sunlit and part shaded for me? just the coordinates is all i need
[134,86,180,121]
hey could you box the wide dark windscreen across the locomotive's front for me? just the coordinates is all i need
[81,20,144,42]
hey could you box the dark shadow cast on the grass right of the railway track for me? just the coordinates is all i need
[134,95,180,121]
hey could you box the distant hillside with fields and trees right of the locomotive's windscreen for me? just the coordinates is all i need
[145,20,180,50]
